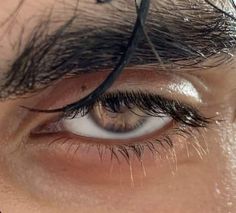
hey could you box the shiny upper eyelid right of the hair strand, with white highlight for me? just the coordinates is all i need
[108,71,204,105]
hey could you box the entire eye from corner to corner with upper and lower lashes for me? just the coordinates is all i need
[31,91,211,163]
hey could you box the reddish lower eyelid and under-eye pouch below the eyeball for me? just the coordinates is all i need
[26,108,208,188]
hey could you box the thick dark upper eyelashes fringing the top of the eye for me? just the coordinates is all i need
[63,91,210,127]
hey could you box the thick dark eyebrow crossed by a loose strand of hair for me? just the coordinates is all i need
[0,1,235,98]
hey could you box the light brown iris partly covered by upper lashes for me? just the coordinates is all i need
[91,104,147,133]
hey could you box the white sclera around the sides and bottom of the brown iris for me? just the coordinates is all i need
[62,114,172,140]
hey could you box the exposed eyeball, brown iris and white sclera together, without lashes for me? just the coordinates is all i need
[62,104,172,140]
